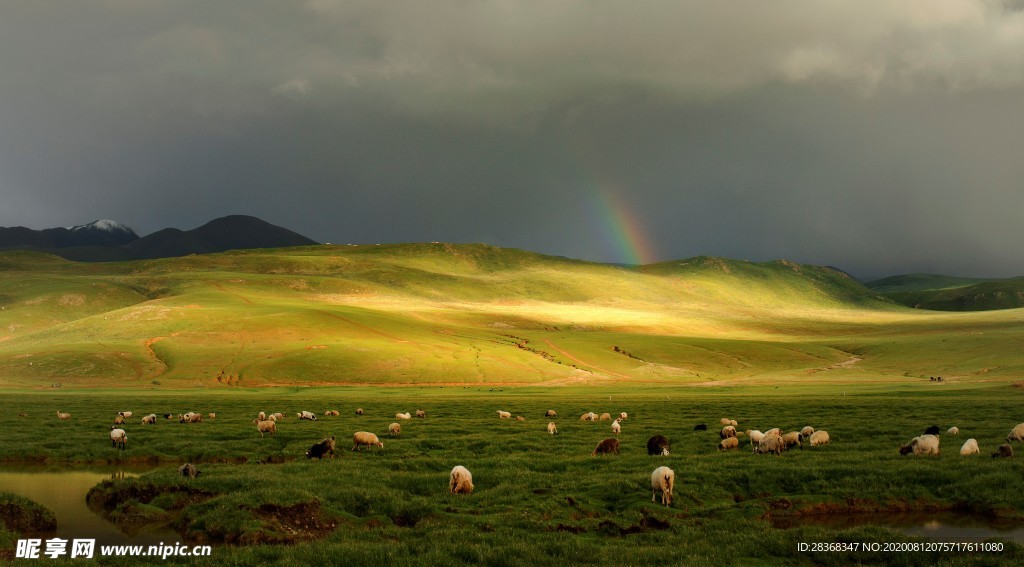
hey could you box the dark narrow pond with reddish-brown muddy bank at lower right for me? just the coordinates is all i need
[771,512,1024,544]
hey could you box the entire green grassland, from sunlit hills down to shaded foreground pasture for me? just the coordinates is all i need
[0,244,1024,565]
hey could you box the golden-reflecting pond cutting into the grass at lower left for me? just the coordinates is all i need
[0,465,181,546]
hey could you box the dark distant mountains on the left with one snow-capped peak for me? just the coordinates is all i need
[0,215,318,262]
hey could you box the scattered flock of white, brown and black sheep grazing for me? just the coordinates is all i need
[56,407,1024,506]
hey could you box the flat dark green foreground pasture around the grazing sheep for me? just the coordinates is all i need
[0,381,1024,565]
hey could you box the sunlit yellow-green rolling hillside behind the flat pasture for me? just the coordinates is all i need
[0,244,1024,387]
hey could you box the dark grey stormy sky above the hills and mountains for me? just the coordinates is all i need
[0,0,1024,279]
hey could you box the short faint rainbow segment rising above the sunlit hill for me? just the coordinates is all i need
[592,189,658,265]
